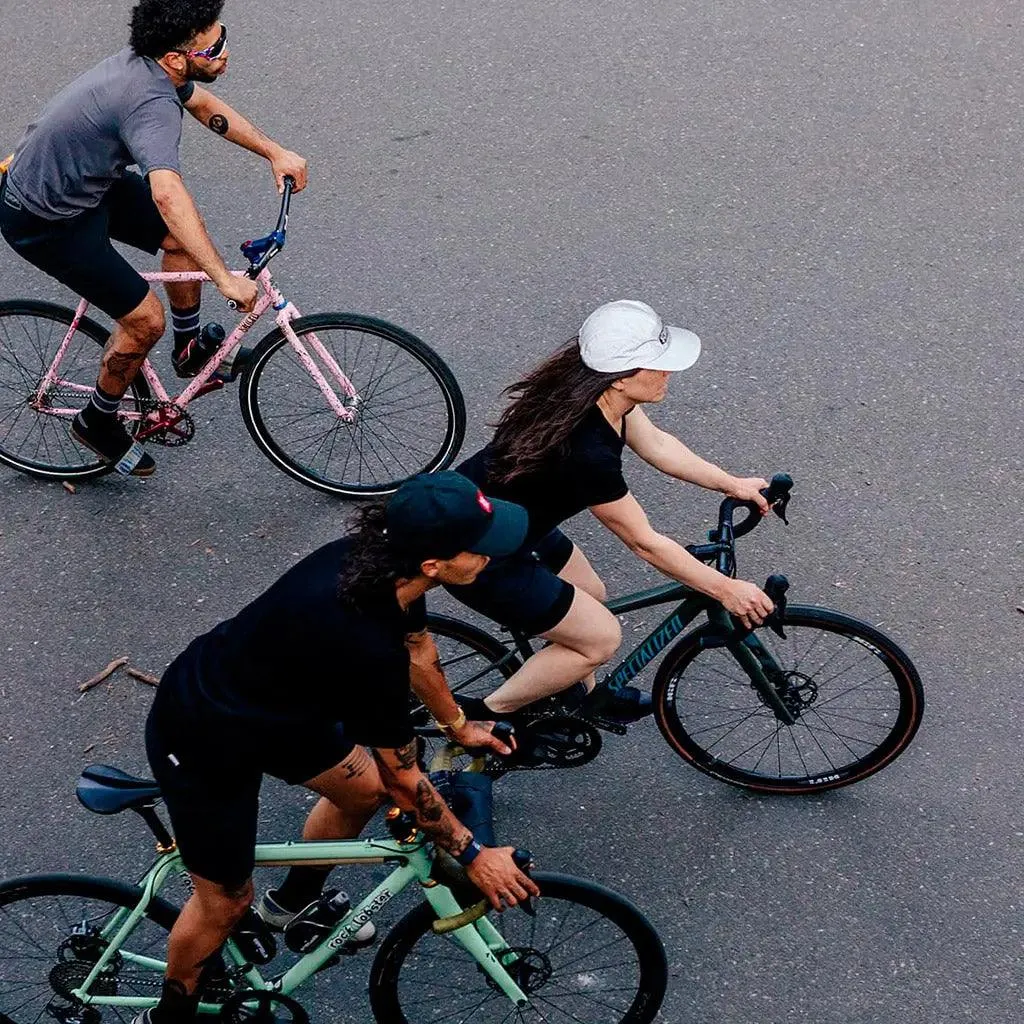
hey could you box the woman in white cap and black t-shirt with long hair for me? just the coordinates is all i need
[447,300,772,720]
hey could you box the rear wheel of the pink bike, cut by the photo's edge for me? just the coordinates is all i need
[0,300,150,480]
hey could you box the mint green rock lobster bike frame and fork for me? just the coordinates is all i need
[67,838,528,1014]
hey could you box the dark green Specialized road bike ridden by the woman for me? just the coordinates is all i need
[417,474,924,794]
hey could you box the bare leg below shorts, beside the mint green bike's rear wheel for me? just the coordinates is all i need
[167,874,253,993]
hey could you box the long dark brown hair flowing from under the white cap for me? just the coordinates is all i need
[487,338,637,483]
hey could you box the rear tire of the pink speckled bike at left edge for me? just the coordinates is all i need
[0,299,152,480]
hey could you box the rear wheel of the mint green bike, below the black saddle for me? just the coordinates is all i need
[0,874,178,1024]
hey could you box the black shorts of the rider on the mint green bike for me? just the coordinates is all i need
[145,662,355,888]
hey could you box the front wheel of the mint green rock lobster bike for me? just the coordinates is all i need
[370,871,669,1024]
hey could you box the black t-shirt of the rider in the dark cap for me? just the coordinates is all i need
[169,539,426,748]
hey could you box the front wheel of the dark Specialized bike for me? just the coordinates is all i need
[654,605,924,794]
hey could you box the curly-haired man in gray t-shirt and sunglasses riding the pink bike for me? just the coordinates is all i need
[0,0,306,476]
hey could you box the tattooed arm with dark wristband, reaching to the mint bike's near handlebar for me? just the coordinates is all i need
[374,740,540,910]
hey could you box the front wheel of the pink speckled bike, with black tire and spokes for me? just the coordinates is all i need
[239,313,466,498]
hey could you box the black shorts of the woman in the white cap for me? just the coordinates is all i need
[445,529,575,636]
